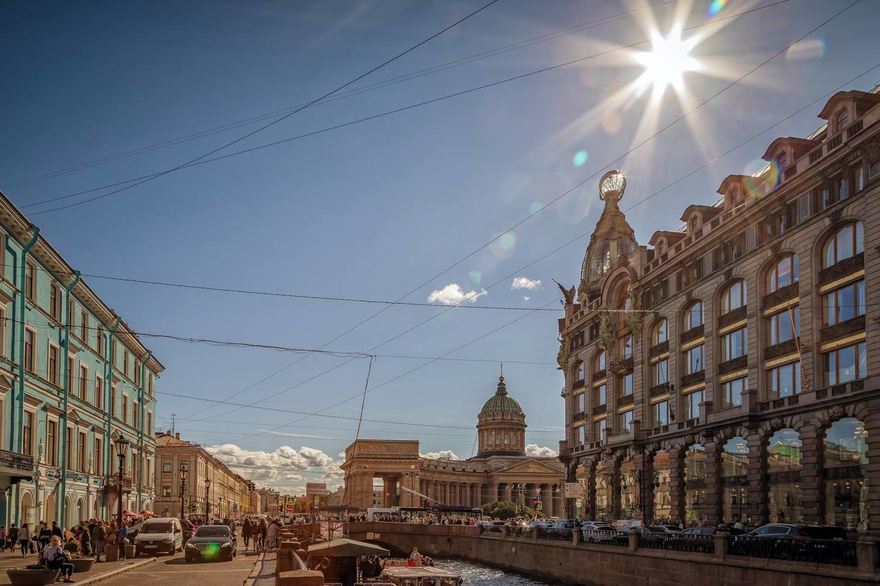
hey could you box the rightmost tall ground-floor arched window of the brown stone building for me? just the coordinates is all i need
[822,417,868,532]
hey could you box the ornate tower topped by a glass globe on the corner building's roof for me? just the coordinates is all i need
[578,171,639,294]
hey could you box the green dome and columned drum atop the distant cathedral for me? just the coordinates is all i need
[477,376,526,458]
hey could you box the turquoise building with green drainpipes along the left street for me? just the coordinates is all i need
[0,192,164,527]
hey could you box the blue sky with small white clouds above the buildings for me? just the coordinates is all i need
[0,0,880,492]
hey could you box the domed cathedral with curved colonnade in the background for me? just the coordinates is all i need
[342,377,564,515]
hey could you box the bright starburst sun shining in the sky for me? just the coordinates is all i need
[633,27,701,99]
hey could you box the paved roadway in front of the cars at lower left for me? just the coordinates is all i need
[102,553,258,586]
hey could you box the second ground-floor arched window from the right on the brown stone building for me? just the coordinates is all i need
[765,429,804,523]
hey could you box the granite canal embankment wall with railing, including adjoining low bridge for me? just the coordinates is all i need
[349,522,880,586]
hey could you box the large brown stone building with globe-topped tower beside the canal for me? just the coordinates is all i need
[558,86,880,533]
